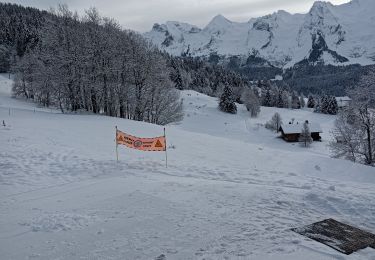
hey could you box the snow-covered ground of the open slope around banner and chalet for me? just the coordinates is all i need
[0,75,375,259]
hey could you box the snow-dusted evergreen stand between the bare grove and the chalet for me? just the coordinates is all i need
[169,57,305,116]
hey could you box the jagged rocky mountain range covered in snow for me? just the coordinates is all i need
[145,0,375,66]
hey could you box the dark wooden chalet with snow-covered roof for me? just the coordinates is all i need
[279,121,323,142]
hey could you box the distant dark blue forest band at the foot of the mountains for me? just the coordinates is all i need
[213,52,374,96]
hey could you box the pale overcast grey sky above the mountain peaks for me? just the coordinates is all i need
[1,0,349,32]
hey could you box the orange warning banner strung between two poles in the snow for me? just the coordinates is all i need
[116,130,166,151]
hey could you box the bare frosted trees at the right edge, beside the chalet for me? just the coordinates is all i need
[330,68,375,166]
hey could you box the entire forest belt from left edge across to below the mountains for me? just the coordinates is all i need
[0,3,374,124]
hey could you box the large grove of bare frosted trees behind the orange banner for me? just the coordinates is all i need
[13,6,183,124]
